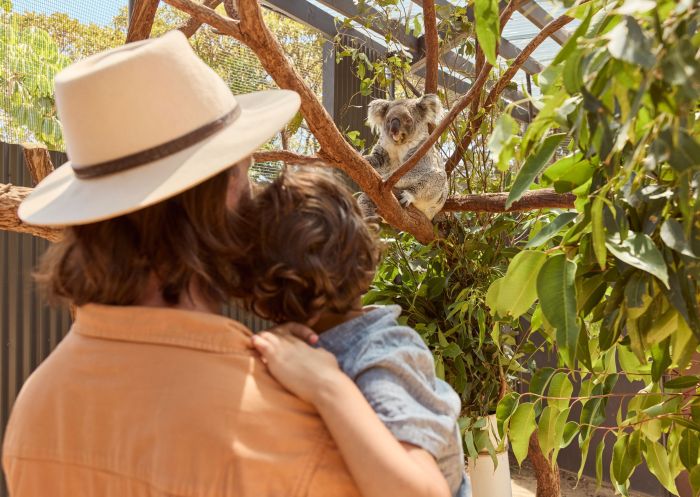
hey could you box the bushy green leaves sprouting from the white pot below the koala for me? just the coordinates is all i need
[365,214,528,457]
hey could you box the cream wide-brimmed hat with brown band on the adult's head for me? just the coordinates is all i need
[18,31,300,226]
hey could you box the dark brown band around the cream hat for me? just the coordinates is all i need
[71,106,241,179]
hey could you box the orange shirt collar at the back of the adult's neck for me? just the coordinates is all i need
[72,304,252,353]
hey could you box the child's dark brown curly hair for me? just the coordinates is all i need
[233,170,380,323]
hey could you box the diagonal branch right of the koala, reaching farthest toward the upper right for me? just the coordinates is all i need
[445,15,573,175]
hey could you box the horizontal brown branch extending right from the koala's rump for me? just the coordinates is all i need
[442,189,576,212]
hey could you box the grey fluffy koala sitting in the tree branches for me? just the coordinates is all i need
[358,95,448,220]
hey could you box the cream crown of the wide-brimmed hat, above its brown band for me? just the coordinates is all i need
[56,30,237,167]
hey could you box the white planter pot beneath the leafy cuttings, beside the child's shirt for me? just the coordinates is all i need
[468,415,513,497]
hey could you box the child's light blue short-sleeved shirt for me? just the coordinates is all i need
[319,305,471,497]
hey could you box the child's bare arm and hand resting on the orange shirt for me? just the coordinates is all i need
[253,332,450,497]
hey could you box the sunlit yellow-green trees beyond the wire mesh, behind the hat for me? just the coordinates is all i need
[0,5,323,153]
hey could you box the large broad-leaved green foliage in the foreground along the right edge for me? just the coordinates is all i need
[488,0,700,495]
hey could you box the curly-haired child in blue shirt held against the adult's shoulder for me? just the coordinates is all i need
[233,170,469,497]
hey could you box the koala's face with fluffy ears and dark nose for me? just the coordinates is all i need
[367,94,442,145]
